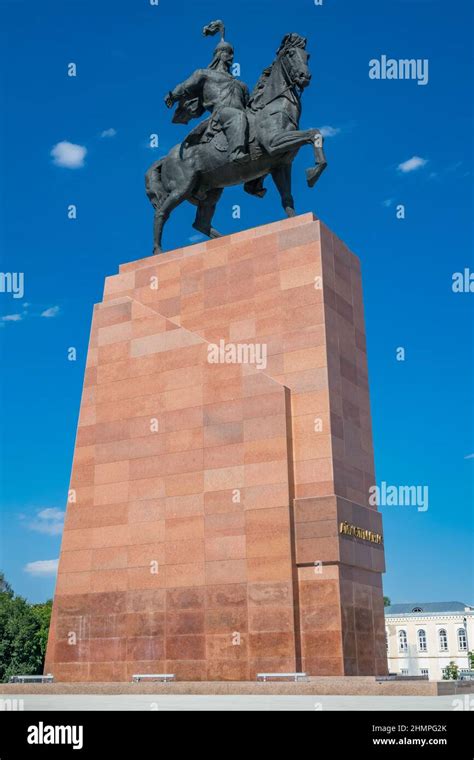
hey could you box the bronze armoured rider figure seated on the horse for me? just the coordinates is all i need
[165,31,249,163]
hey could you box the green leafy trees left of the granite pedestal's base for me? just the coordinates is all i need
[0,573,51,682]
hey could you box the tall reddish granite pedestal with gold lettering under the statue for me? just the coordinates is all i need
[45,214,387,681]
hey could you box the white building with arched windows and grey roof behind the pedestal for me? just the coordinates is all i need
[385,602,474,681]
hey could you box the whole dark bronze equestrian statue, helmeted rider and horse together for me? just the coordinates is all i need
[145,21,327,253]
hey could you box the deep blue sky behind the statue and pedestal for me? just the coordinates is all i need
[0,0,474,603]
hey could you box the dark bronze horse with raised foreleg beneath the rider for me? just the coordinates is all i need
[145,34,327,253]
